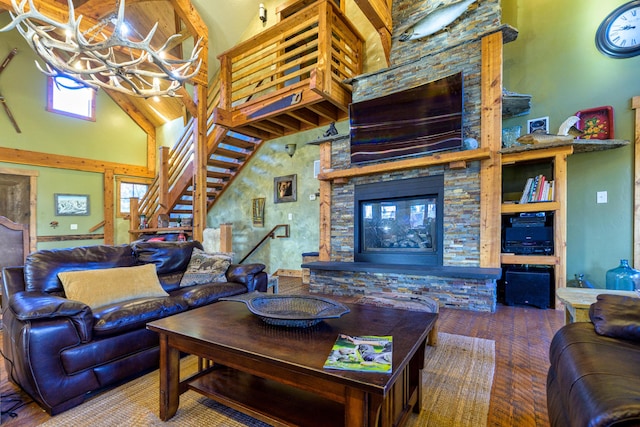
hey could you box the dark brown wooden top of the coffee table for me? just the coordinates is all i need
[147,301,438,394]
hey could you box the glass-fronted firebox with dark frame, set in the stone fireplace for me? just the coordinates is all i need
[354,175,444,266]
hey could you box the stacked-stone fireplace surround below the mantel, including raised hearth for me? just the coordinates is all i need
[302,142,501,312]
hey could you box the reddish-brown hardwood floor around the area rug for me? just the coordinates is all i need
[0,277,564,427]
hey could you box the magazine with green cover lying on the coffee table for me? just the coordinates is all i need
[324,334,393,373]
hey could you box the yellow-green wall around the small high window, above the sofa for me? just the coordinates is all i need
[0,13,147,249]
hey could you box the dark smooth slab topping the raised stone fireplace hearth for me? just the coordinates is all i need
[301,261,502,280]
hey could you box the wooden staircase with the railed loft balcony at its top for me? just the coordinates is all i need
[130,0,364,237]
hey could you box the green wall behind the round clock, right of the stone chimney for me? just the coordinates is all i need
[502,0,640,287]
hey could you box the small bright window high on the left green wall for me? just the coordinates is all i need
[47,76,96,122]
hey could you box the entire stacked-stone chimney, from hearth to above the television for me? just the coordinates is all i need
[302,0,508,312]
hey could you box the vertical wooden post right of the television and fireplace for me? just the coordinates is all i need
[480,31,503,268]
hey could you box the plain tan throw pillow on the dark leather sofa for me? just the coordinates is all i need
[58,264,169,309]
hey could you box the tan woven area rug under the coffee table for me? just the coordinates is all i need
[42,333,495,427]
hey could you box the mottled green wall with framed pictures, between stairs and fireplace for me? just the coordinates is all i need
[207,122,349,273]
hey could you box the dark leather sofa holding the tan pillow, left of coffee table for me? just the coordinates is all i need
[2,242,267,415]
